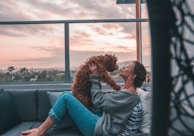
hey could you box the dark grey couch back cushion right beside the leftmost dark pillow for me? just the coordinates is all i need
[8,89,37,121]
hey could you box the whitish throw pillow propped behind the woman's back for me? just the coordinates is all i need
[137,88,152,133]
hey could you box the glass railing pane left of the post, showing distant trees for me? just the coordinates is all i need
[0,24,64,81]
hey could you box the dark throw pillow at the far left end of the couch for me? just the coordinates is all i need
[0,89,20,134]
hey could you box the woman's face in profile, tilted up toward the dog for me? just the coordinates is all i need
[120,62,135,79]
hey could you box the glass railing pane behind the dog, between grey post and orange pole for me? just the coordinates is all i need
[70,22,137,82]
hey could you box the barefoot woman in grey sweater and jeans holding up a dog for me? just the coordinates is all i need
[21,61,146,136]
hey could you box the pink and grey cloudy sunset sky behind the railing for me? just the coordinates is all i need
[0,0,150,69]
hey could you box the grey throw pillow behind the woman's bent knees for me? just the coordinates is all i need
[47,91,75,129]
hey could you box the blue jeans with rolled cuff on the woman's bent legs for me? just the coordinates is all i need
[49,92,99,136]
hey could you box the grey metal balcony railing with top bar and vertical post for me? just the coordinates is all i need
[0,19,149,83]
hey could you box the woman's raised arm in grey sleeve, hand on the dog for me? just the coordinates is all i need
[89,64,138,113]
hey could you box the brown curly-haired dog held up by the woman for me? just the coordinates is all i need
[72,54,121,108]
